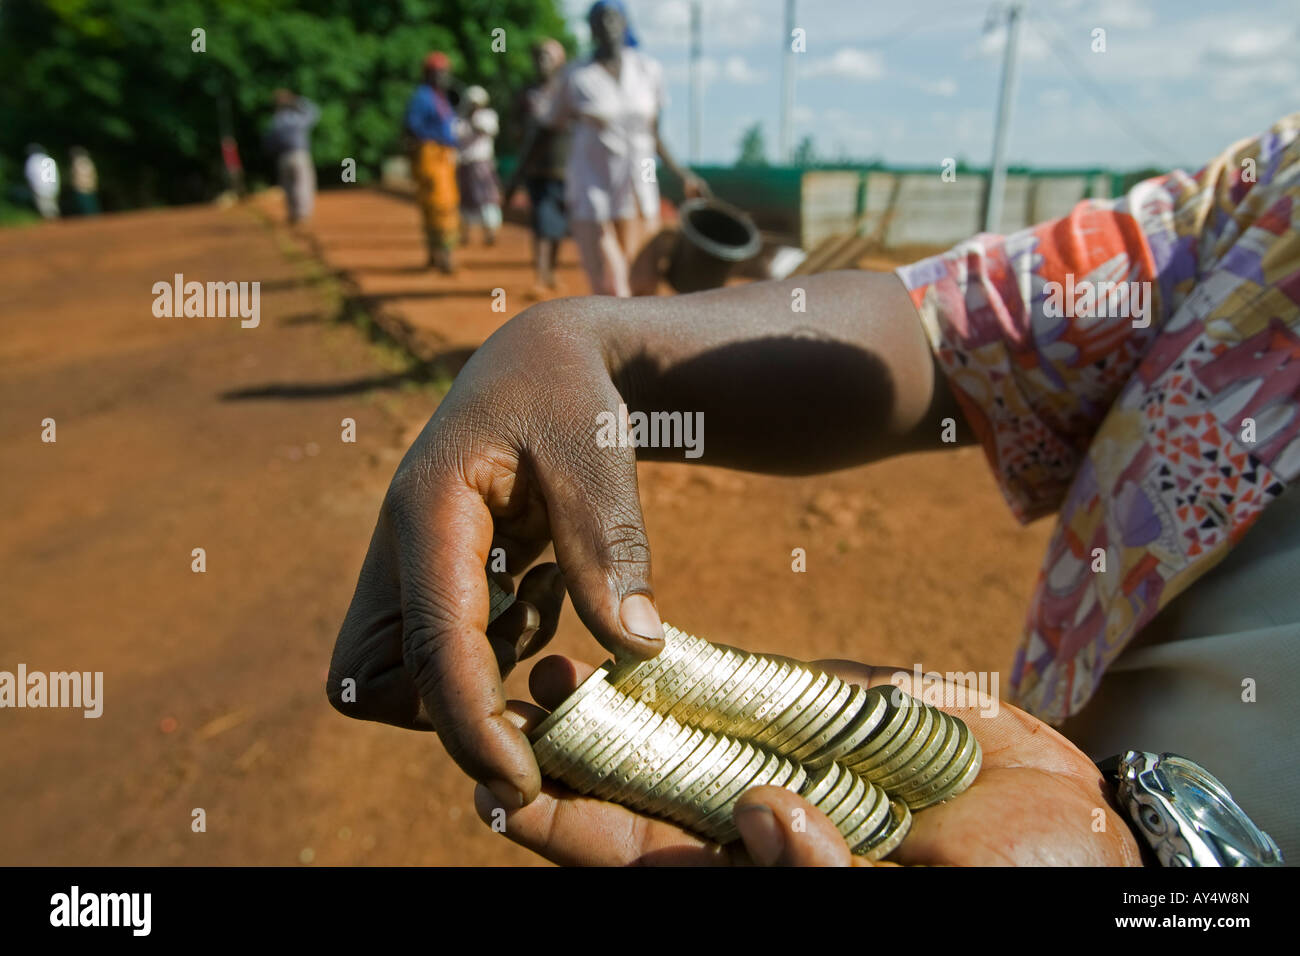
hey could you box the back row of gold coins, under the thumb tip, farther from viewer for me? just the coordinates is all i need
[610,627,982,810]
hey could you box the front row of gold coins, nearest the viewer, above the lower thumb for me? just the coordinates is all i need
[530,667,911,858]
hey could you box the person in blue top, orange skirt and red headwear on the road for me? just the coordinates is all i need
[406,52,460,274]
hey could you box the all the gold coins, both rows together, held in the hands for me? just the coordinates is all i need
[489,581,982,858]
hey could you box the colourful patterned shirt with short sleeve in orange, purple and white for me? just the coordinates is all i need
[898,113,1300,723]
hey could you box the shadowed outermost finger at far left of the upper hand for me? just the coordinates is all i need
[325,512,433,731]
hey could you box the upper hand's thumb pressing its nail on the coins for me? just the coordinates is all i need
[533,389,663,658]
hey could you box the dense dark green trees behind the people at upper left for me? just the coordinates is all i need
[0,0,572,208]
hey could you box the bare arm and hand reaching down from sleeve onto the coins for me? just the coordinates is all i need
[328,272,961,806]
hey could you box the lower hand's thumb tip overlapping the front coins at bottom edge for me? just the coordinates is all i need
[733,787,853,866]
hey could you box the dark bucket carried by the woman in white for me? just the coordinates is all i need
[667,199,763,293]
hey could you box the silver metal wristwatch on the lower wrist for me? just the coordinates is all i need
[1097,750,1282,866]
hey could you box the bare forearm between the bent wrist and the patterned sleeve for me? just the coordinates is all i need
[566,272,967,473]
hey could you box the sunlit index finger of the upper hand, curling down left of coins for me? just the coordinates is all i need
[385,472,541,806]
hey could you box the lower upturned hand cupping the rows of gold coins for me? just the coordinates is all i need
[475,658,1141,866]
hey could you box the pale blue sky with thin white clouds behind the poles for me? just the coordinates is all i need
[563,0,1300,169]
